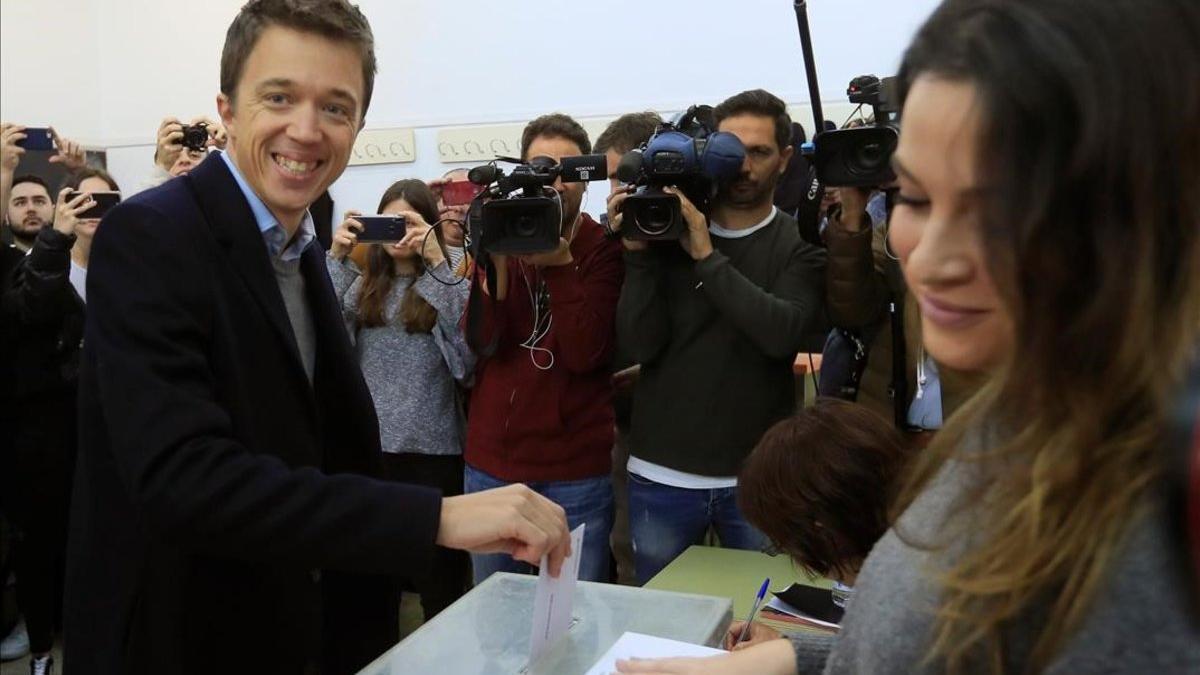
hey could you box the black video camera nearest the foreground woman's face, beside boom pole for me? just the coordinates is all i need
[812,74,900,186]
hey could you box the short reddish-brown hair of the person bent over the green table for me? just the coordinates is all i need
[738,399,907,577]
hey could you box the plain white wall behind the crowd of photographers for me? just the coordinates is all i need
[0,0,936,213]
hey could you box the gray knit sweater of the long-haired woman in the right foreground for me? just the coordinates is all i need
[791,429,1200,674]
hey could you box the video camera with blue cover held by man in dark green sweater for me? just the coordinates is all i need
[617,106,745,241]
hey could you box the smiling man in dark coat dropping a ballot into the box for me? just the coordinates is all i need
[65,0,570,674]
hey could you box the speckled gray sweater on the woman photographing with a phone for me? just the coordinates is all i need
[325,256,475,455]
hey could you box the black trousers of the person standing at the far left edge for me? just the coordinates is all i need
[0,389,76,653]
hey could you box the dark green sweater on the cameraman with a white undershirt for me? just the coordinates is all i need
[617,210,826,476]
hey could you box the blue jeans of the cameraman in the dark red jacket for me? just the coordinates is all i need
[463,464,613,585]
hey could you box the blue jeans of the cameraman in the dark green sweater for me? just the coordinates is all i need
[629,473,767,585]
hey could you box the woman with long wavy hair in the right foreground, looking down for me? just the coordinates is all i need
[619,0,1200,674]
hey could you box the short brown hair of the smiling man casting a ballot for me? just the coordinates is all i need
[221,0,376,120]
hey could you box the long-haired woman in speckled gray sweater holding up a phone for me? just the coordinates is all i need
[325,180,475,620]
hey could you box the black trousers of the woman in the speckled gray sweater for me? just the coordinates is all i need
[383,453,470,621]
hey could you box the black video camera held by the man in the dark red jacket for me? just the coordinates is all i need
[467,155,608,258]
